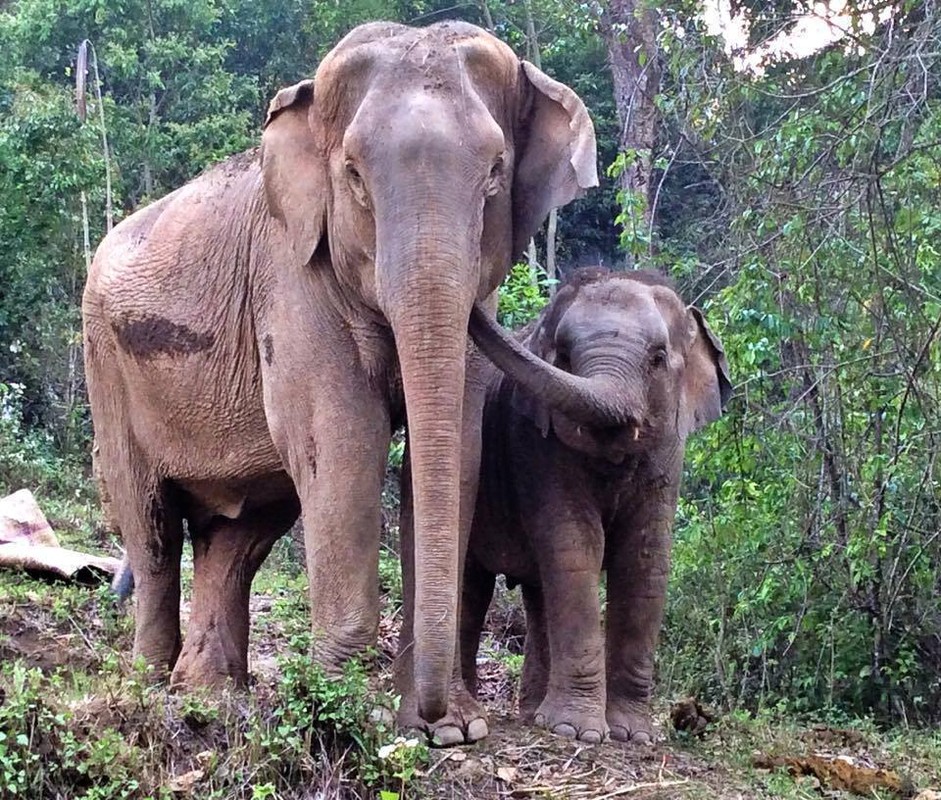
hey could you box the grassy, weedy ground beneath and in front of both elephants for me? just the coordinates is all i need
[0,478,941,800]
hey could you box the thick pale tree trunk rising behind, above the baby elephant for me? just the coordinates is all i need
[603,0,660,256]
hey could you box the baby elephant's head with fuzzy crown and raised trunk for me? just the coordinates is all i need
[474,269,731,463]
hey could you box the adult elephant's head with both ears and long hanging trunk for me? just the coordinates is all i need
[261,22,597,722]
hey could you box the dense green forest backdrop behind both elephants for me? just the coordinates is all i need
[0,0,941,724]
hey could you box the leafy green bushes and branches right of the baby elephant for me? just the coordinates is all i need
[661,0,941,722]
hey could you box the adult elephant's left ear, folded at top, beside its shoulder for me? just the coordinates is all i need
[261,80,327,264]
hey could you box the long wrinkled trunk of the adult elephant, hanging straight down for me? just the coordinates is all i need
[377,225,479,723]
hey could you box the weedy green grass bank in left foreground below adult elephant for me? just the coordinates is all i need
[0,632,427,800]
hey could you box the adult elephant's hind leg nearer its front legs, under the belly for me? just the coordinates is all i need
[171,501,299,686]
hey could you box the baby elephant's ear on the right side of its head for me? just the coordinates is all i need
[679,306,732,437]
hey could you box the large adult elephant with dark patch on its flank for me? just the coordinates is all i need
[83,22,597,741]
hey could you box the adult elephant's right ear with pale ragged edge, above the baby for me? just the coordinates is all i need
[513,61,598,258]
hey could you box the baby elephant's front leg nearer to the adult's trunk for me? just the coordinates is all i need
[532,503,608,743]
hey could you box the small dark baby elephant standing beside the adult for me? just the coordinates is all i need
[461,269,731,742]
